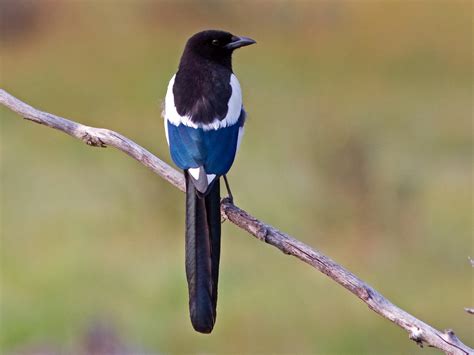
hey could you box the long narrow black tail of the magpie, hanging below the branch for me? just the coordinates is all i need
[185,172,221,333]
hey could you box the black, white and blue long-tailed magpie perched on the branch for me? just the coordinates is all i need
[163,30,255,333]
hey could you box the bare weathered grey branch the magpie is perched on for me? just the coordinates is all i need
[0,89,474,354]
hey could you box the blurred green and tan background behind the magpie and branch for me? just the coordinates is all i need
[0,0,474,354]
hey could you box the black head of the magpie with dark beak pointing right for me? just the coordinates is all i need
[181,30,255,68]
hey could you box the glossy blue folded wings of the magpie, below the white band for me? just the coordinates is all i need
[166,109,245,176]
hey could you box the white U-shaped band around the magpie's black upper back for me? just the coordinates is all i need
[163,74,242,132]
